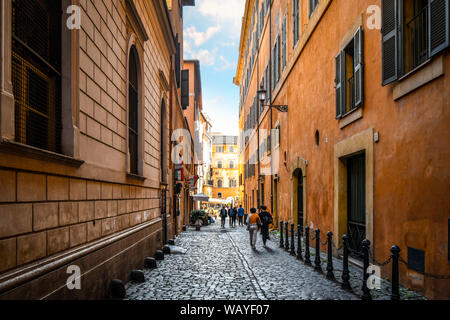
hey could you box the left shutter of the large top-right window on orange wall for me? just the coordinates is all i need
[381,0,398,86]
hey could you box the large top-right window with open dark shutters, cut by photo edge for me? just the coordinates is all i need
[381,0,450,85]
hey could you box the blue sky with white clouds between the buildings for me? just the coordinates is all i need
[184,0,245,135]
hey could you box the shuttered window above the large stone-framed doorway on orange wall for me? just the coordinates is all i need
[335,28,364,119]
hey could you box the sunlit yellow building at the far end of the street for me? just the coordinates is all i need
[206,133,239,205]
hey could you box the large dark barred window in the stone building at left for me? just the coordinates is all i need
[11,0,61,153]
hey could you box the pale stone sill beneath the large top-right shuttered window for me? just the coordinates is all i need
[393,55,444,101]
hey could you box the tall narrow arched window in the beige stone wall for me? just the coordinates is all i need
[128,45,139,174]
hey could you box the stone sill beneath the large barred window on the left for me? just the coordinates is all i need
[0,139,84,167]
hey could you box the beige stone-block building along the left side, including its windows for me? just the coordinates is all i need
[0,0,192,299]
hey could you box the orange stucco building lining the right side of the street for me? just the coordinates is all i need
[234,0,450,298]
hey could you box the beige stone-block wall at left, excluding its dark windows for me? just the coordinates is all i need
[0,0,181,295]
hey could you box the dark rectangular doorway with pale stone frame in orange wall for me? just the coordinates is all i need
[347,154,366,257]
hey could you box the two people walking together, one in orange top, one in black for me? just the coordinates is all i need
[247,206,273,249]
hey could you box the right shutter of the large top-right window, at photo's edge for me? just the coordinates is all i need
[428,0,450,56]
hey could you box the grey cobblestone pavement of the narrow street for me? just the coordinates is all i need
[126,221,424,300]
